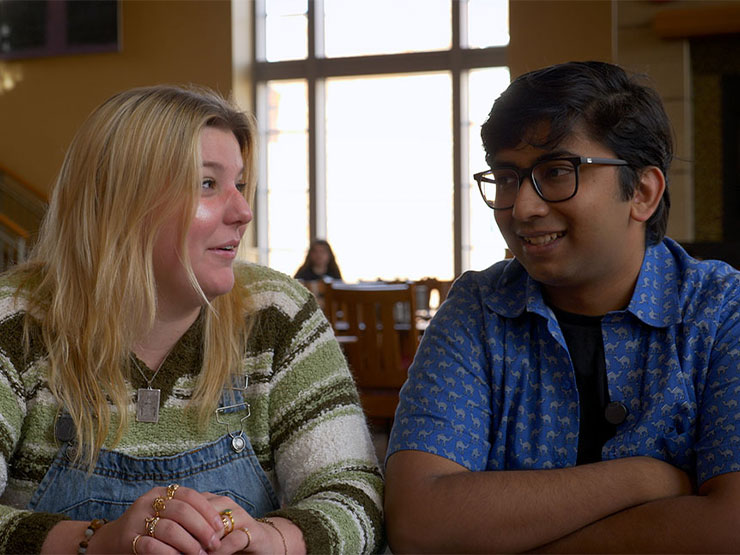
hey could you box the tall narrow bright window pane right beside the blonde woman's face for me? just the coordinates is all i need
[260,81,309,275]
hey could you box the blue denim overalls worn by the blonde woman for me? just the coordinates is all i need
[28,390,279,520]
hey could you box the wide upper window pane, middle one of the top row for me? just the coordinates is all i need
[324,0,452,58]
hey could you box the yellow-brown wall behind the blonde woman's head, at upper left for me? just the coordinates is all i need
[0,0,232,191]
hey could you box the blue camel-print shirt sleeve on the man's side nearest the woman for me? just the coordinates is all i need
[388,274,491,471]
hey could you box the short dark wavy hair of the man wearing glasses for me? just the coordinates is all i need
[481,62,673,245]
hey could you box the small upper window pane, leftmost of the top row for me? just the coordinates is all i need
[265,0,308,62]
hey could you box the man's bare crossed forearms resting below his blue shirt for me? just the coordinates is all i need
[385,451,740,553]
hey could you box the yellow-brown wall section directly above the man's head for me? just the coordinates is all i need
[508,0,614,78]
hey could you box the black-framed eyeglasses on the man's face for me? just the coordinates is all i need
[473,156,629,210]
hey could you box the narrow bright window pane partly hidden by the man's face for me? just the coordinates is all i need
[468,67,511,270]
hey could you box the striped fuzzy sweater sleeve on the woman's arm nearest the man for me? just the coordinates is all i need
[243,268,384,553]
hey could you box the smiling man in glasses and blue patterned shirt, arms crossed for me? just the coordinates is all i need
[385,58,740,553]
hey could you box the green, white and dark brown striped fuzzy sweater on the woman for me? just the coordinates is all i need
[0,264,384,554]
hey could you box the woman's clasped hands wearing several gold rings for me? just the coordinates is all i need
[90,484,283,555]
